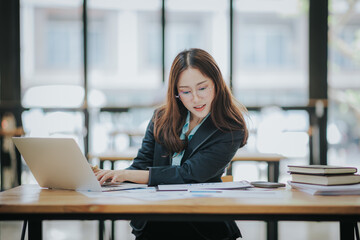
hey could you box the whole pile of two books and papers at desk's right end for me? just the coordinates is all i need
[288,165,360,195]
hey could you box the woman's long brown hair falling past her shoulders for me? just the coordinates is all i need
[153,48,248,153]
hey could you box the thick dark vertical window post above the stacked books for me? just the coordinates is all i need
[309,0,328,165]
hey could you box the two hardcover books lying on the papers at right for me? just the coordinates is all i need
[288,165,360,186]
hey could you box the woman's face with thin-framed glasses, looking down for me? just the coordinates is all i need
[177,68,215,121]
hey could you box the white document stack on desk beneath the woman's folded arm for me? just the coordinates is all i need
[158,180,252,191]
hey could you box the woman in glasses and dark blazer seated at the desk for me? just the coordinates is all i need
[96,49,248,239]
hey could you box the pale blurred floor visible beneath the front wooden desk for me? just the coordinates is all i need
[0,221,340,240]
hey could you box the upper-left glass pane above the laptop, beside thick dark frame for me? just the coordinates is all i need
[20,0,84,107]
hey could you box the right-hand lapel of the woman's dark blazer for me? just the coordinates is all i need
[181,116,218,163]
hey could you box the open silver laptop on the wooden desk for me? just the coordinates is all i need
[12,137,147,192]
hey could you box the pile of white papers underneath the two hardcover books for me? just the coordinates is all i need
[288,182,360,196]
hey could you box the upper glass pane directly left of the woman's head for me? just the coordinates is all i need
[88,0,163,107]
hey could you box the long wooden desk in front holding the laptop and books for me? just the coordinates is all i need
[0,185,360,240]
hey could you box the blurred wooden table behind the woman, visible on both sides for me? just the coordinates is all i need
[88,149,285,182]
